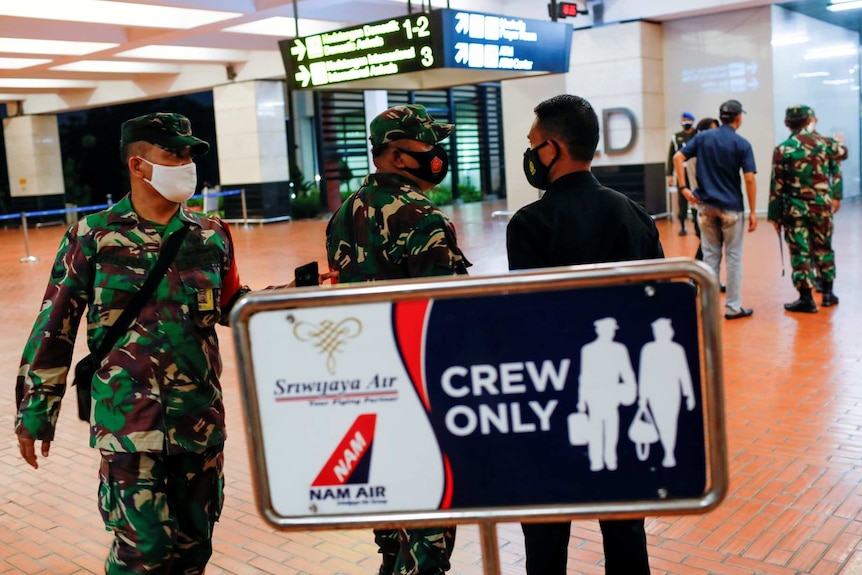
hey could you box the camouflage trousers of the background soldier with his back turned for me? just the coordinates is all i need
[784,213,835,289]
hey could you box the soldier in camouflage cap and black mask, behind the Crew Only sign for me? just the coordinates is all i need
[326,105,470,575]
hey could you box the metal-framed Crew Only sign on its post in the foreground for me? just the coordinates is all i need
[232,258,727,574]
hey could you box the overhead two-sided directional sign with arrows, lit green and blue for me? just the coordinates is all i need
[279,9,572,90]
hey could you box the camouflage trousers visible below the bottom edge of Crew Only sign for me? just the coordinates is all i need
[374,525,455,575]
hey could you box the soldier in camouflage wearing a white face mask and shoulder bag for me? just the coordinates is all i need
[15,113,253,575]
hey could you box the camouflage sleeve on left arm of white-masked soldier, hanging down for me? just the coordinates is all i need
[15,223,93,441]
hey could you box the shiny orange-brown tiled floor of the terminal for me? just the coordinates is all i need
[0,196,862,575]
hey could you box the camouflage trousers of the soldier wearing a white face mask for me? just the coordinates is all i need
[99,446,224,575]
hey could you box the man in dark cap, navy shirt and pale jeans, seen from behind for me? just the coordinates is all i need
[673,100,757,319]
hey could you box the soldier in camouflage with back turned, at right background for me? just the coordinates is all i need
[768,106,841,313]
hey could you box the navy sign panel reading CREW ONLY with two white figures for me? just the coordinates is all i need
[425,282,707,509]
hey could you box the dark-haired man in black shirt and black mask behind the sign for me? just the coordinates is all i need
[506,94,664,575]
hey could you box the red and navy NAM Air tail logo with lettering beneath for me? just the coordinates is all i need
[309,413,386,505]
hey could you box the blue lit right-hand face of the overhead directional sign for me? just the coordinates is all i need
[435,10,572,73]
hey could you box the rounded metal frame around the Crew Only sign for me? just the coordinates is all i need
[231,258,729,530]
